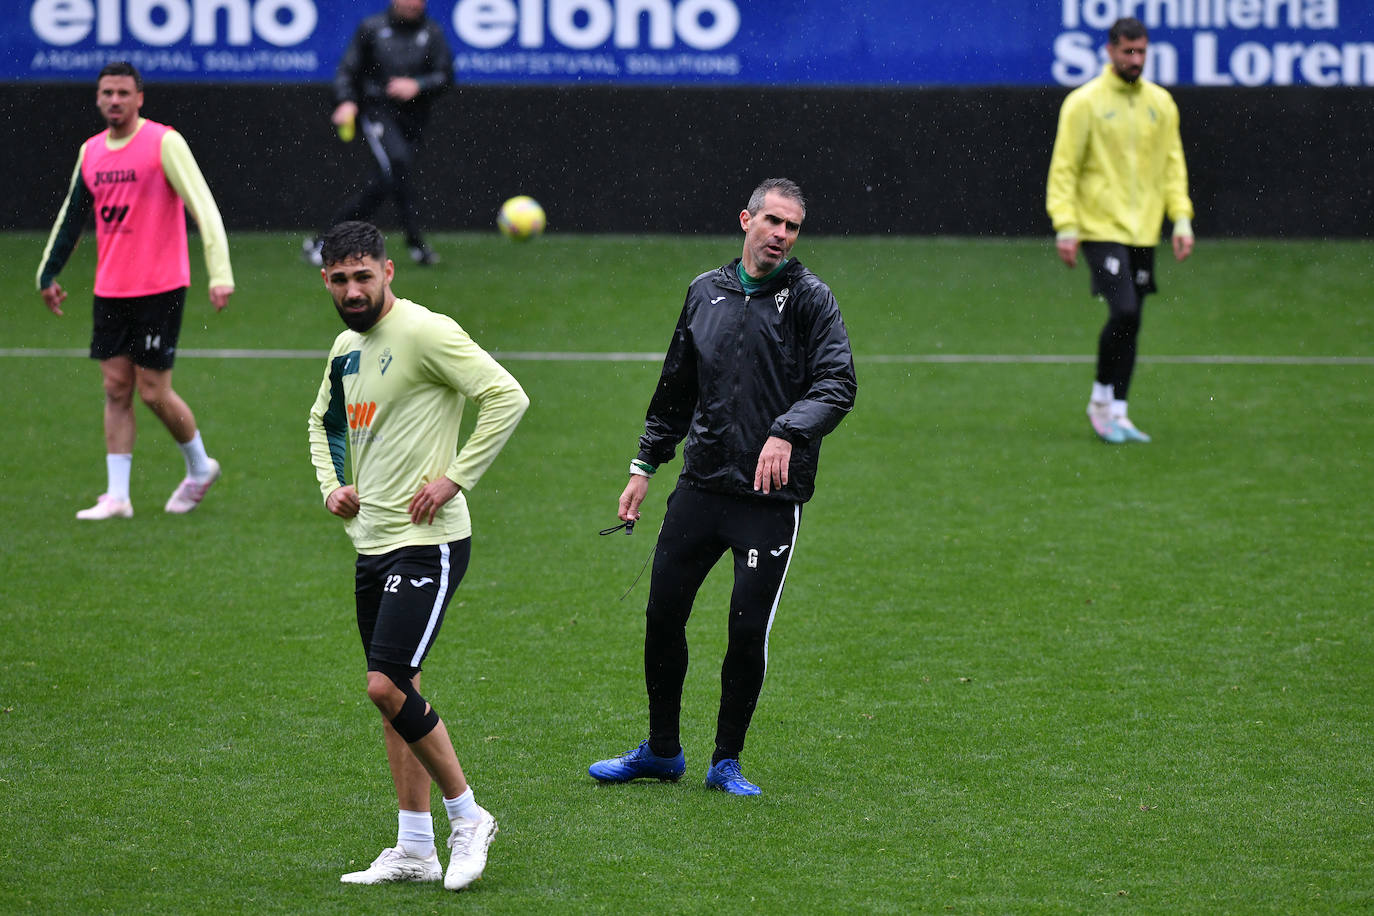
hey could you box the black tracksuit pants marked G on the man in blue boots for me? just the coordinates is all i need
[644,486,801,762]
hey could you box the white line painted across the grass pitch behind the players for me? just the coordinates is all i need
[0,347,1374,365]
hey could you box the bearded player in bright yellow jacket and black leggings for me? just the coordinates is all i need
[1046,18,1193,444]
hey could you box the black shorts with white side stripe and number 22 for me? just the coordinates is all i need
[354,537,473,674]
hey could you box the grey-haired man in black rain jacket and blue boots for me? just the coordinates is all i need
[588,179,857,795]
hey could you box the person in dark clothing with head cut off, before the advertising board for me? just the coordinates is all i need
[301,0,453,266]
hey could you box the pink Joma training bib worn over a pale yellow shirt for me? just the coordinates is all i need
[81,121,191,297]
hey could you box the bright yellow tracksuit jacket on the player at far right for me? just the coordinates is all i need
[1046,65,1193,247]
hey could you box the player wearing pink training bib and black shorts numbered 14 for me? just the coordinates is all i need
[38,62,234,519]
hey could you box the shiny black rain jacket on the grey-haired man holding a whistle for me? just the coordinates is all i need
[639,258,859,503]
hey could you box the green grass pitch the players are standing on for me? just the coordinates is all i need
[0,231,1374,913]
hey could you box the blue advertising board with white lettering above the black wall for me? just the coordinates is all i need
[8,0,1374,87]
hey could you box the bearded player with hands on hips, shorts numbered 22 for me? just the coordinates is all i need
[309,222,529,890]
